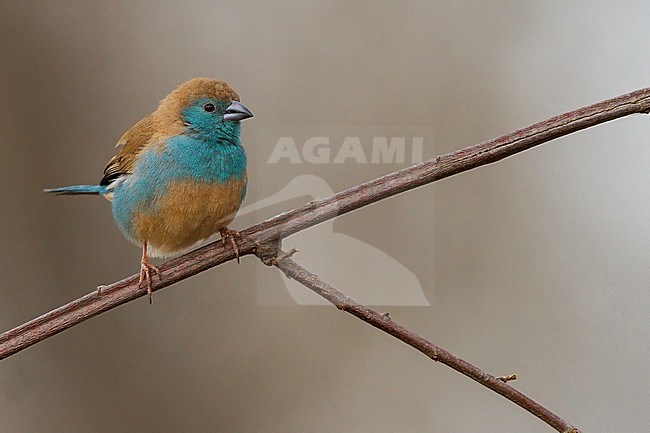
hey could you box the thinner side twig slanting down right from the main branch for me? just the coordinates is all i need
[258,246,580,433]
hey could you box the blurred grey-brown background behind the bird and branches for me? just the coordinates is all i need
[0,1,650,433]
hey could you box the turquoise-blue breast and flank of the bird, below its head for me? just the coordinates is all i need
[112,135,246,243]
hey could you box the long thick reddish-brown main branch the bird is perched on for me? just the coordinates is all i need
[0,88,650,426]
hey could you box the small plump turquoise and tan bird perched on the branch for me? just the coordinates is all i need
[44,78,253,303]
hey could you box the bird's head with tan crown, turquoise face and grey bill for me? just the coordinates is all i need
[158,78,253,144]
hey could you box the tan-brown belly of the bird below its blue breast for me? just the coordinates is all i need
[134,177,245,257]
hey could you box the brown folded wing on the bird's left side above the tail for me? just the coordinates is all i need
[99,113,156,185]
